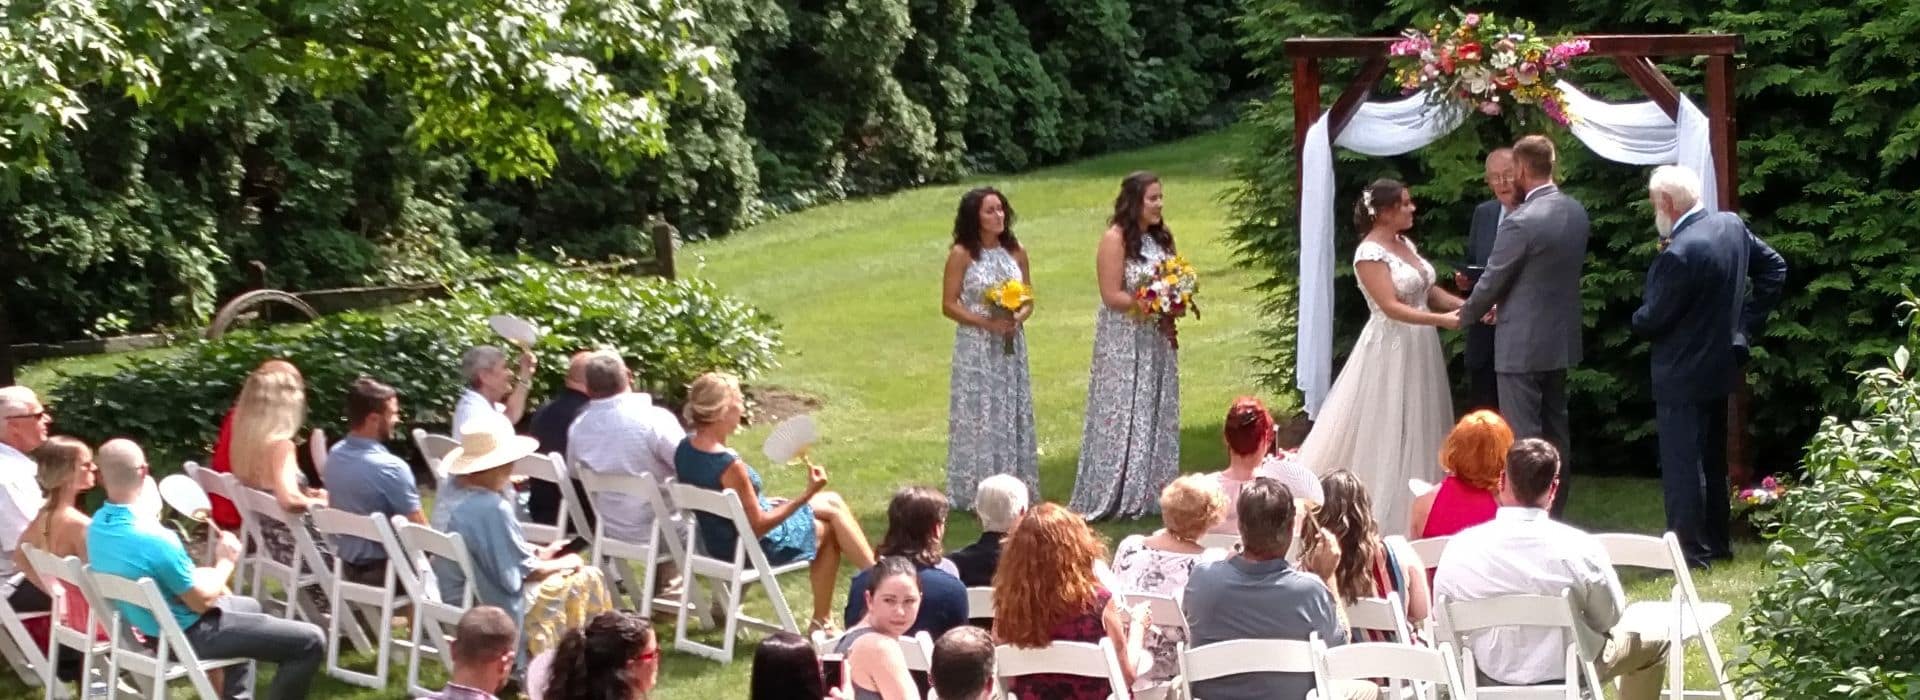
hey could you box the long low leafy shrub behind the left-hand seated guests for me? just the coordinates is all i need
[48,265,780,468]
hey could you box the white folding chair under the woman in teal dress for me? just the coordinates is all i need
[672,477,810,664]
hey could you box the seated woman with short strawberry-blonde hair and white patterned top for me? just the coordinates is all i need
[1114,474,1227,688]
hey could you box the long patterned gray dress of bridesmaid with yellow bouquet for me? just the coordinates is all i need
[947,247,1041,510]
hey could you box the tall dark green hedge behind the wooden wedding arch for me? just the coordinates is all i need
[1233,0,1920,472]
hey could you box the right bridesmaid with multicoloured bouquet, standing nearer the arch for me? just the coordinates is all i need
[1071,173,1181,520]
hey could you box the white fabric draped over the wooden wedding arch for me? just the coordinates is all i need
[1294,81,1718,416]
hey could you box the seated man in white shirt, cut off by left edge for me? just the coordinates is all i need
[0,381,54,598]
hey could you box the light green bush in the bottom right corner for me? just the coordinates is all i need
[1734,293,1920,698]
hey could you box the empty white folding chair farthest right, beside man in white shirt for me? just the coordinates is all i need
[1594,533,1734,700]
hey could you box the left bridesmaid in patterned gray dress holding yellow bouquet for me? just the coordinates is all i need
[941,188,1041,510]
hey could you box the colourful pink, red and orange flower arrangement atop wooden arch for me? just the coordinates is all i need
[1386,8,1592,127]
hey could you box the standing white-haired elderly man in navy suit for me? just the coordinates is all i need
[1634,165,1786,568]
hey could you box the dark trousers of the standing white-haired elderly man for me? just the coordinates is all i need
[1653,399,1734,566]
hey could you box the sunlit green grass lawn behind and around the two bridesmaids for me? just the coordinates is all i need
[0,130,1763,698]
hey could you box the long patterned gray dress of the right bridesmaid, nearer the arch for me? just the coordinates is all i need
[1071,238,1181,520]
